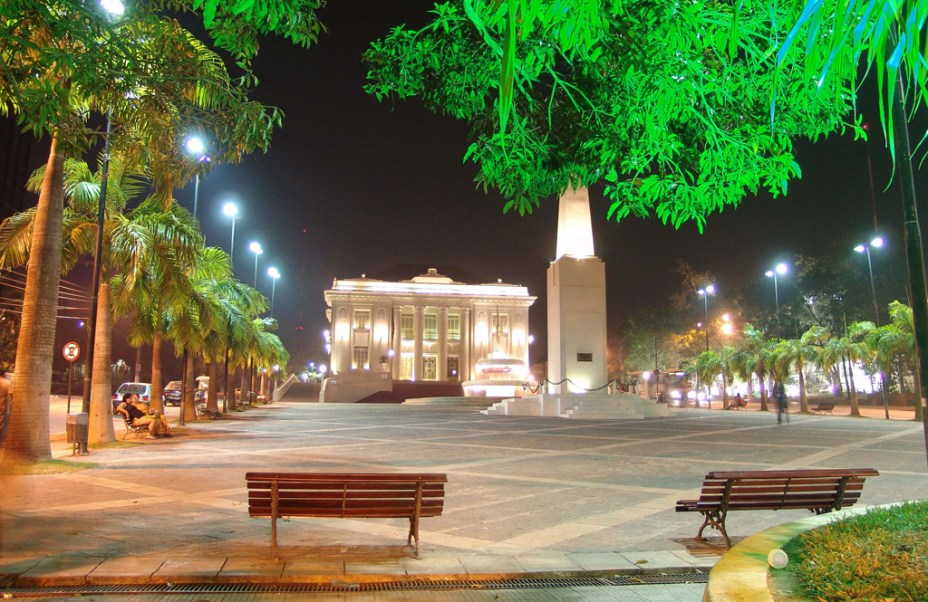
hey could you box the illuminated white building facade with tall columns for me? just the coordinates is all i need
[325,268,536,381]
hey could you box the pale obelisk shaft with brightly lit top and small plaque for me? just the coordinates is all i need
[548,186,608,393]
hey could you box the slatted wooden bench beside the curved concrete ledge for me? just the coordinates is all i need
[677,468,880,548]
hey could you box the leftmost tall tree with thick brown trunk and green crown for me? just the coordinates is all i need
[0,1,290,462]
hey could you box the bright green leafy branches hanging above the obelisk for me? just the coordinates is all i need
[364,0,876,230]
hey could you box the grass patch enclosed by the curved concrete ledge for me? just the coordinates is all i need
[783,502,928,600]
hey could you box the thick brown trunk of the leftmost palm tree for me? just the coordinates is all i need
[0,133,64,463]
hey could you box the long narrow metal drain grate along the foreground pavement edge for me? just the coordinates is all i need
[0,572,709,597]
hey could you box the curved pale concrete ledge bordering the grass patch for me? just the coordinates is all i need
[703,504,876,602]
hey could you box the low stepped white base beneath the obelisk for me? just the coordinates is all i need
[480,393,670,420]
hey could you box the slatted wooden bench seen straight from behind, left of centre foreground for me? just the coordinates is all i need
[245,472,448,558]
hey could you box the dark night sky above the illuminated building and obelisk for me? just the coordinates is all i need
[161,0,928,361]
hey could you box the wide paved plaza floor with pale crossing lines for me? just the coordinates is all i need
[0,392,928,600]
